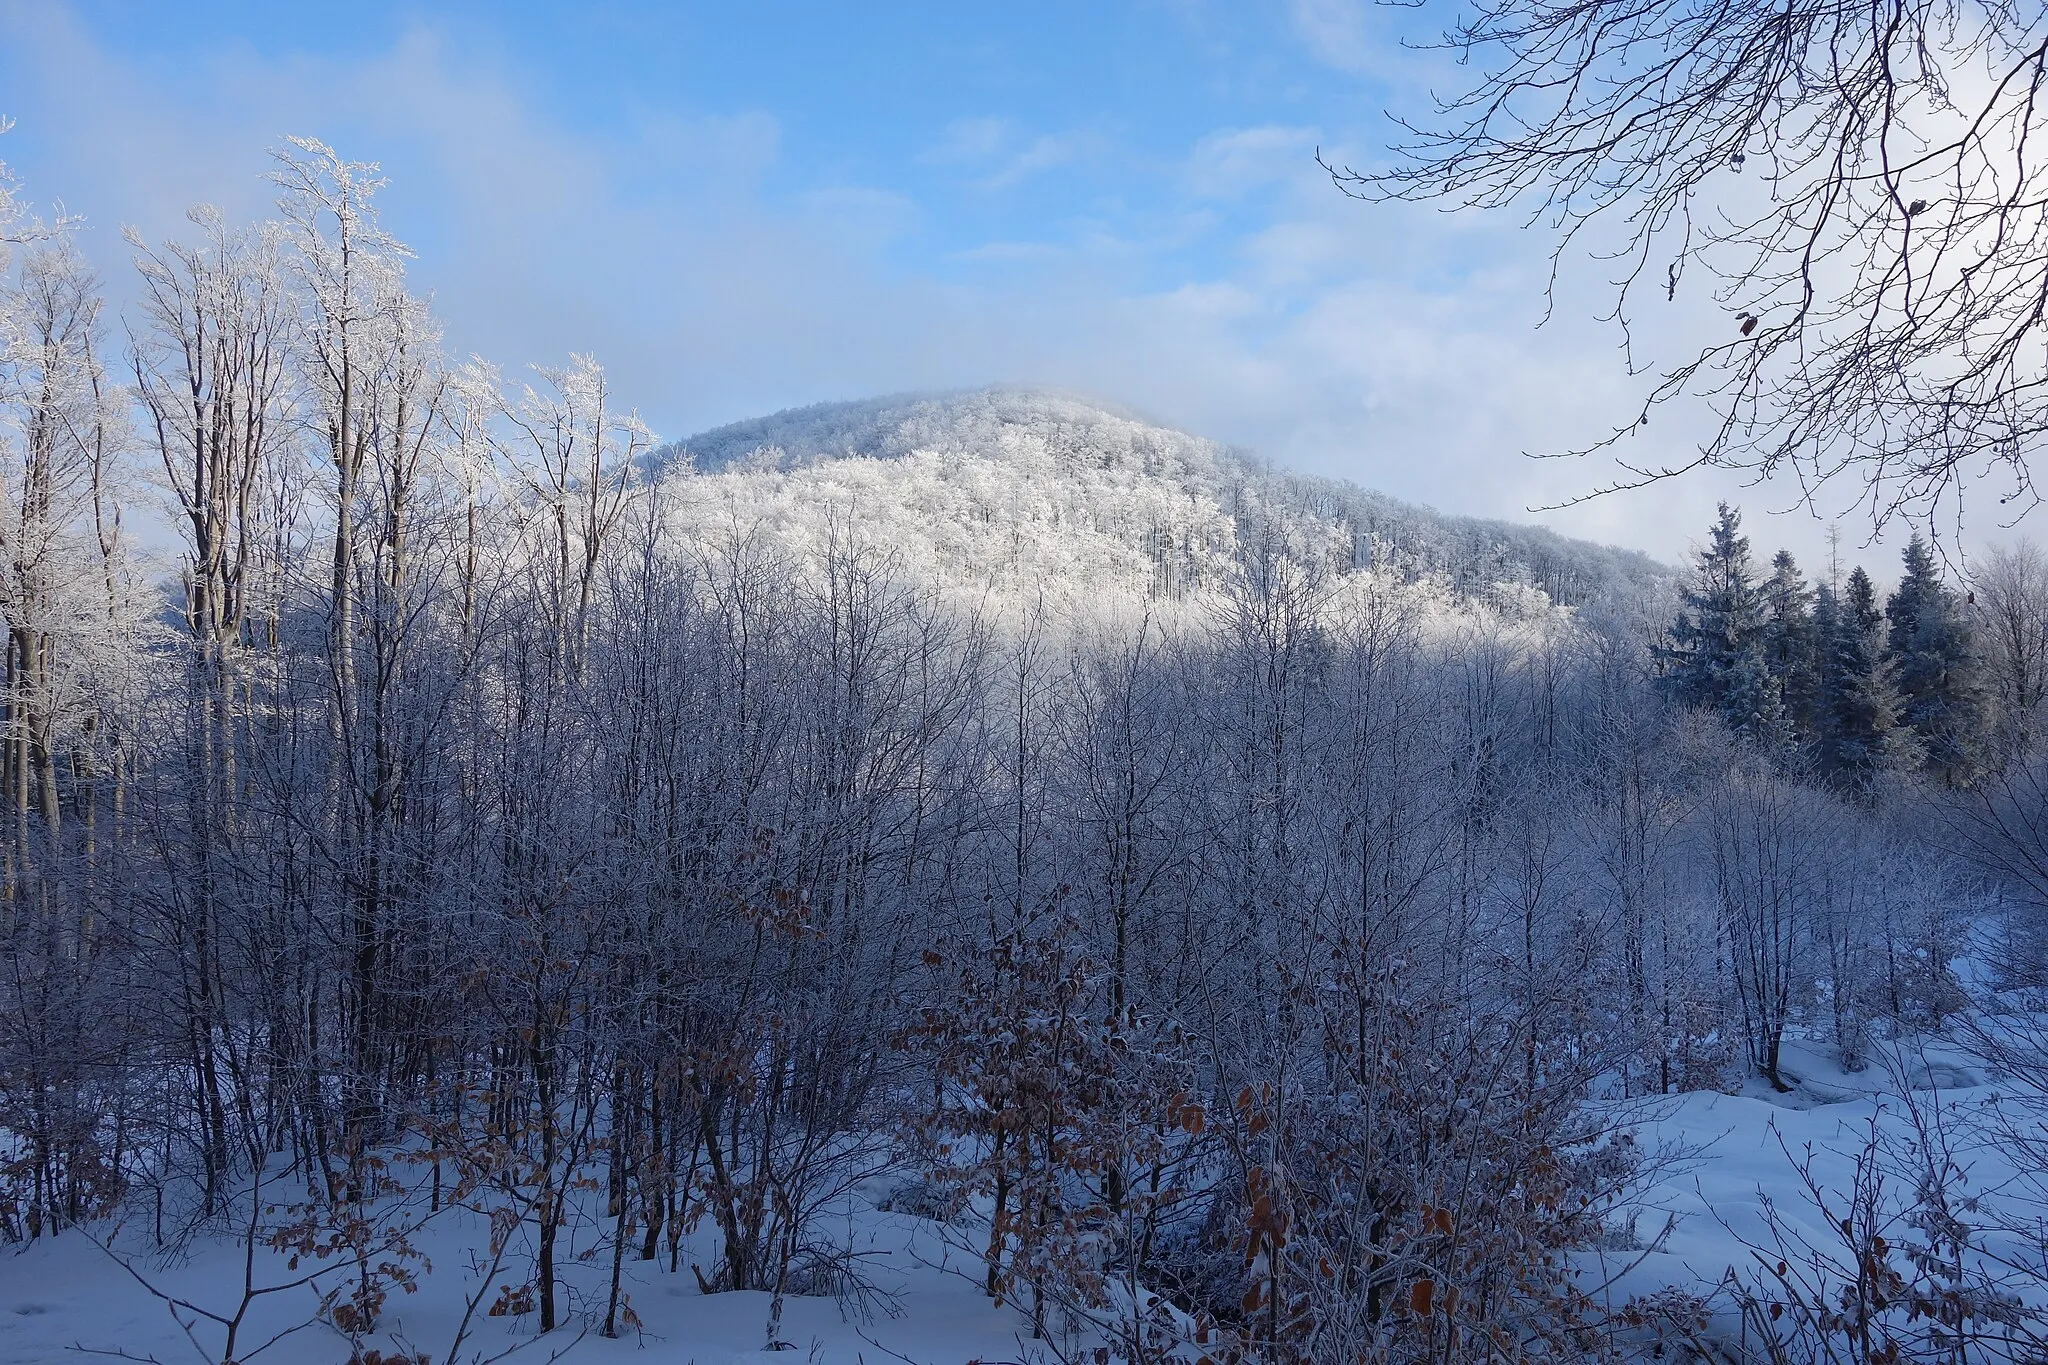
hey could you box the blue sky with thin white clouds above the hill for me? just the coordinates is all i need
[0,0,1851,559]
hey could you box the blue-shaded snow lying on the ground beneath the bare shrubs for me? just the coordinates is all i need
[0,1042,2042,1365]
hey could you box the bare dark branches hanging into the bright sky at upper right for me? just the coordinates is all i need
[1331,0,2048,526]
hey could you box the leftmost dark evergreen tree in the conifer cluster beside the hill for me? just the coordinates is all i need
[1659,503,1790,751]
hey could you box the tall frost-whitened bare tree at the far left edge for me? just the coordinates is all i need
[0,241,145,1236]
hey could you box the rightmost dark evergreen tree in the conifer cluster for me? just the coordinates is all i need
[1884,536,1985,786]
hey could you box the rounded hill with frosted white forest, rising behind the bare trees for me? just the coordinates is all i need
[657,387,1671,606]
